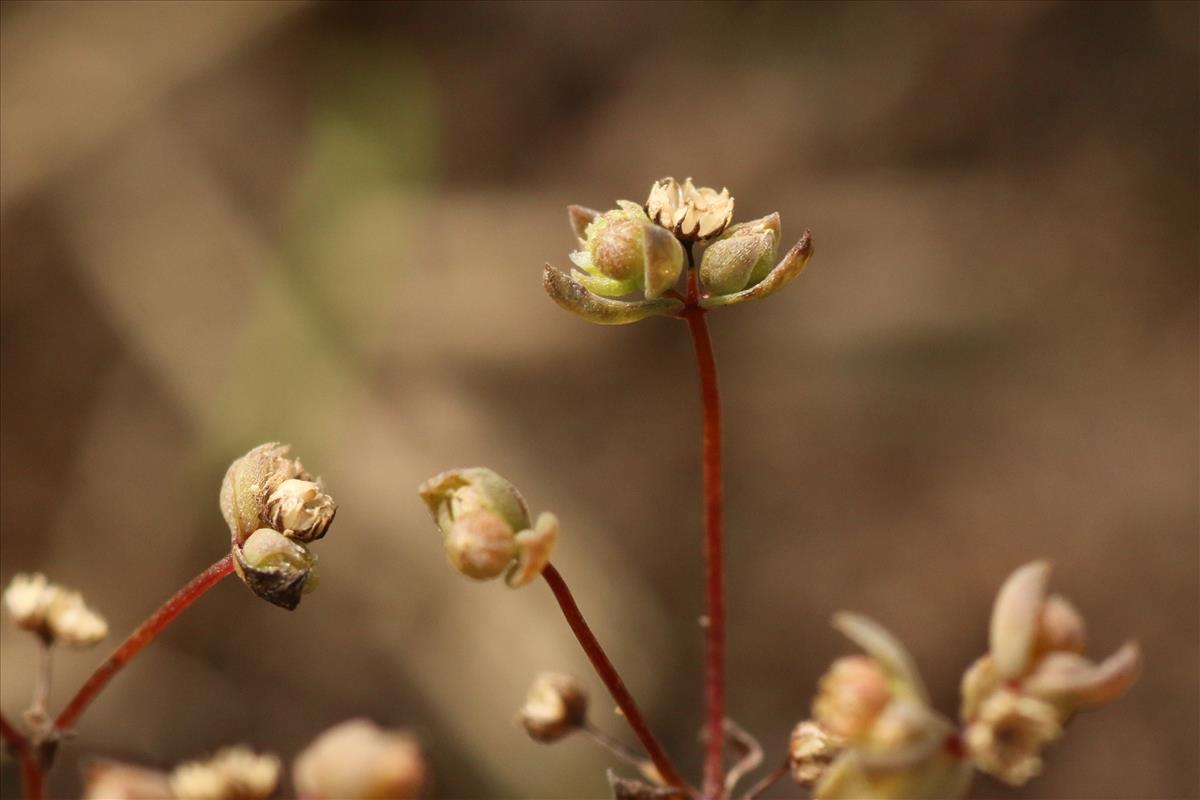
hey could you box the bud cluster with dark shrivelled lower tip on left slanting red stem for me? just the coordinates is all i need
[221,441,337,609]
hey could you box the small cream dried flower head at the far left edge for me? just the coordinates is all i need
[4,573,108,648]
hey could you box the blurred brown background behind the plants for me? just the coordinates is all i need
[0,2,1200,799]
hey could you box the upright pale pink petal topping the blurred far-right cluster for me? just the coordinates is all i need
[989,560,1050,680]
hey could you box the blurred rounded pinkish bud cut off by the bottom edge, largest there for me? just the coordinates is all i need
[292,720,427,800]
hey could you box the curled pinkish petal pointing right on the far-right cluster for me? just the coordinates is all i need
[1021,642,1141,715]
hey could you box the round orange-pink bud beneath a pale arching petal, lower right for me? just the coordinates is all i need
[812,656,892,740]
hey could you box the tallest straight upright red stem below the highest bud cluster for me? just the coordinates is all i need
[683,266,725,800]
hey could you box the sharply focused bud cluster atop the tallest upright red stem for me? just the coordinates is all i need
[542,178,812,325]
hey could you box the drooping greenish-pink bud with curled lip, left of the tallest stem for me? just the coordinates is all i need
[418,467,558,588]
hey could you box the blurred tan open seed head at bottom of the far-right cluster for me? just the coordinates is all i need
[966,688,1062,786]
